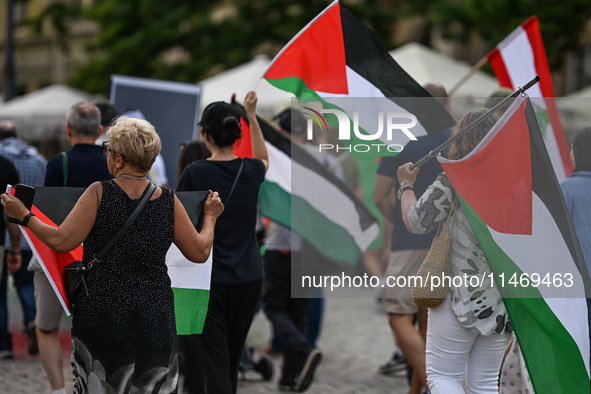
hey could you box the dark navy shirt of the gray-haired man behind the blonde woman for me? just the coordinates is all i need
[45,144,113,187]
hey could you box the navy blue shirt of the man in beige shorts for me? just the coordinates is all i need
[378,129,451,252]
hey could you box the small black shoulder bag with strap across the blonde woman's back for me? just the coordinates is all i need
[62,182,156,309]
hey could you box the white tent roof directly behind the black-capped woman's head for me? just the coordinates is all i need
[198,55,293,117]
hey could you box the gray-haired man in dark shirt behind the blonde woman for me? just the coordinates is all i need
[35,101,113,394]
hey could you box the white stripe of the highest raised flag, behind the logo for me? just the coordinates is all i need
[317,66,427,146]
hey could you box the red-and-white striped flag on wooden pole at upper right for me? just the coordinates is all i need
[488,16,573,181]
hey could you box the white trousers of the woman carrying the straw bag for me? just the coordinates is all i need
[426,296,511,394]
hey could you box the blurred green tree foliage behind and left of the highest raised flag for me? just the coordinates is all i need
[70,0,395,94]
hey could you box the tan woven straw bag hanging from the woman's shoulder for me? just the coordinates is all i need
[411,197,458,308]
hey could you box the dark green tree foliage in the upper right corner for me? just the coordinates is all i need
[402,0,591,70]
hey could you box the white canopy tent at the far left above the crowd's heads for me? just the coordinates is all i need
[0,85,93,140]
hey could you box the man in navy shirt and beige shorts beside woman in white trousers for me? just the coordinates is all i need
[374,83,451,394]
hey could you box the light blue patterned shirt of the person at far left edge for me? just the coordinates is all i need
[0,137,45,250]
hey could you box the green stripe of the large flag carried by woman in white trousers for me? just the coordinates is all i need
[460,198,590,394]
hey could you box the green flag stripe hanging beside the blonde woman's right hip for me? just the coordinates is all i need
[172,287,209,335]
